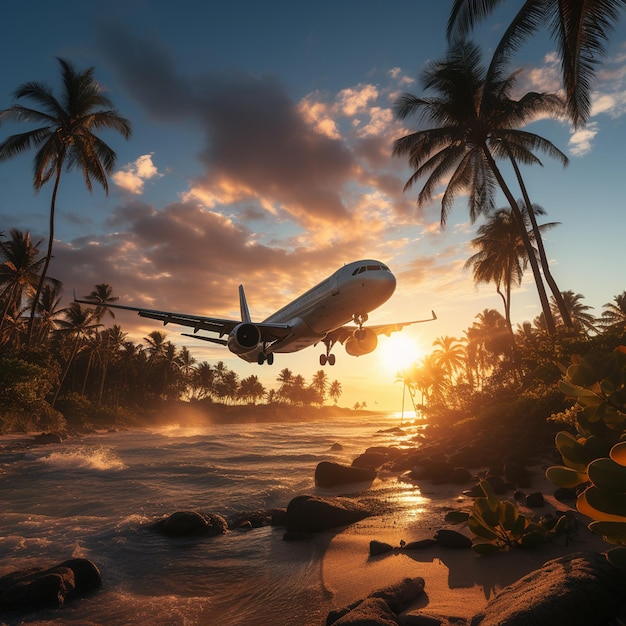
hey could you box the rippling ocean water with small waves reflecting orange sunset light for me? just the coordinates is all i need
[0,415,422,626]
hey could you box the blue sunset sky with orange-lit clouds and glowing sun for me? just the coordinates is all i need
[0,0,626,411]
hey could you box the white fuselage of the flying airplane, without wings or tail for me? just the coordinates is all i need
[238,260,396,362]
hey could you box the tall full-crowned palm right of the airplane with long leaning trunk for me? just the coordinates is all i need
[393,42,568,334]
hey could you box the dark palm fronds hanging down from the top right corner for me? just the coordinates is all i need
[447,0,626,126]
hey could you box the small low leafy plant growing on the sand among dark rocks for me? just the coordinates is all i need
[467,480,571,554]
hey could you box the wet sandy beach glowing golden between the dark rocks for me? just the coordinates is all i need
[320,458,607,618]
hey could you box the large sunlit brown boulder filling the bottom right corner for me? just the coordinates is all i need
[470,552,626,626]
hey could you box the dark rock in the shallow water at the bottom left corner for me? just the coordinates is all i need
[0,559,102,610]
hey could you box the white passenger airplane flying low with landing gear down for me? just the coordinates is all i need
[74,259,437,367]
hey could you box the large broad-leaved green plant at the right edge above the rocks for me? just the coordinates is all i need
[546,346,626,567]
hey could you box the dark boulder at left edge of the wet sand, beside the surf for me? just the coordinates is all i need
[287,496,372,532]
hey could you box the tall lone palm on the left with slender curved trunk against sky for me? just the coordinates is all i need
[0,59,131,343]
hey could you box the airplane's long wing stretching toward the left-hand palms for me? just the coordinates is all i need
[74,296,293,345]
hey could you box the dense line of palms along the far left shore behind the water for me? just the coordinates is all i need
[0,229,342,430]
